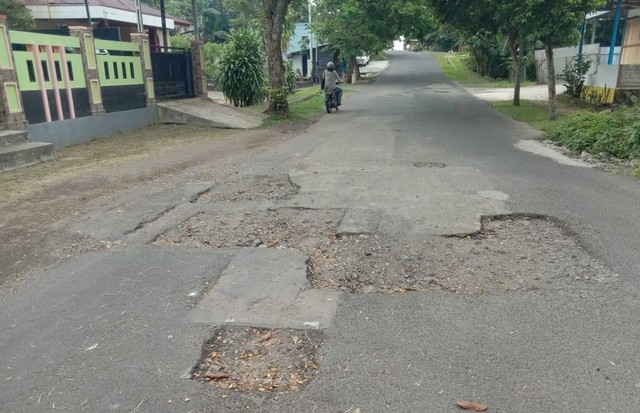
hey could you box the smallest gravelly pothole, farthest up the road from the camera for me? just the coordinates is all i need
[198,175,300,203]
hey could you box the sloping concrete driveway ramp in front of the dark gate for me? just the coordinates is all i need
[158,98,267,129]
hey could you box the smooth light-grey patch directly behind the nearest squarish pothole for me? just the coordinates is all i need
[187,248,339,329]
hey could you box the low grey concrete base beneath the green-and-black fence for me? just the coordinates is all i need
[27,107,158,148]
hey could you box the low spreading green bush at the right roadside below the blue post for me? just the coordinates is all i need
[547,107,640,159]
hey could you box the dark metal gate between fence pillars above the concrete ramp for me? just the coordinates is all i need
[151,46,195,99]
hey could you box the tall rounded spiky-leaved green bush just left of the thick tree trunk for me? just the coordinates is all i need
[216,30,267,107]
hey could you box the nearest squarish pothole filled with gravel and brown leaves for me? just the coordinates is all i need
[192,327,324,392]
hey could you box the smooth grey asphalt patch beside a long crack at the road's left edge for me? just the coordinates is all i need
[73,182,211,240]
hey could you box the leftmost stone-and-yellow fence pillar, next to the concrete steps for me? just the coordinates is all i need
[0,14,29,130]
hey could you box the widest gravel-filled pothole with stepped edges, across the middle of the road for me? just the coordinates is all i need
[157,208,617,295]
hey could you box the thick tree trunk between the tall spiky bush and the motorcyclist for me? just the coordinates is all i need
[262,0,291,115]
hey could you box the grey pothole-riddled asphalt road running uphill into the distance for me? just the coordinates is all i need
[0,53,640,413]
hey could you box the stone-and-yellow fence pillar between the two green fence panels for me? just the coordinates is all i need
[69,26,106,116]
